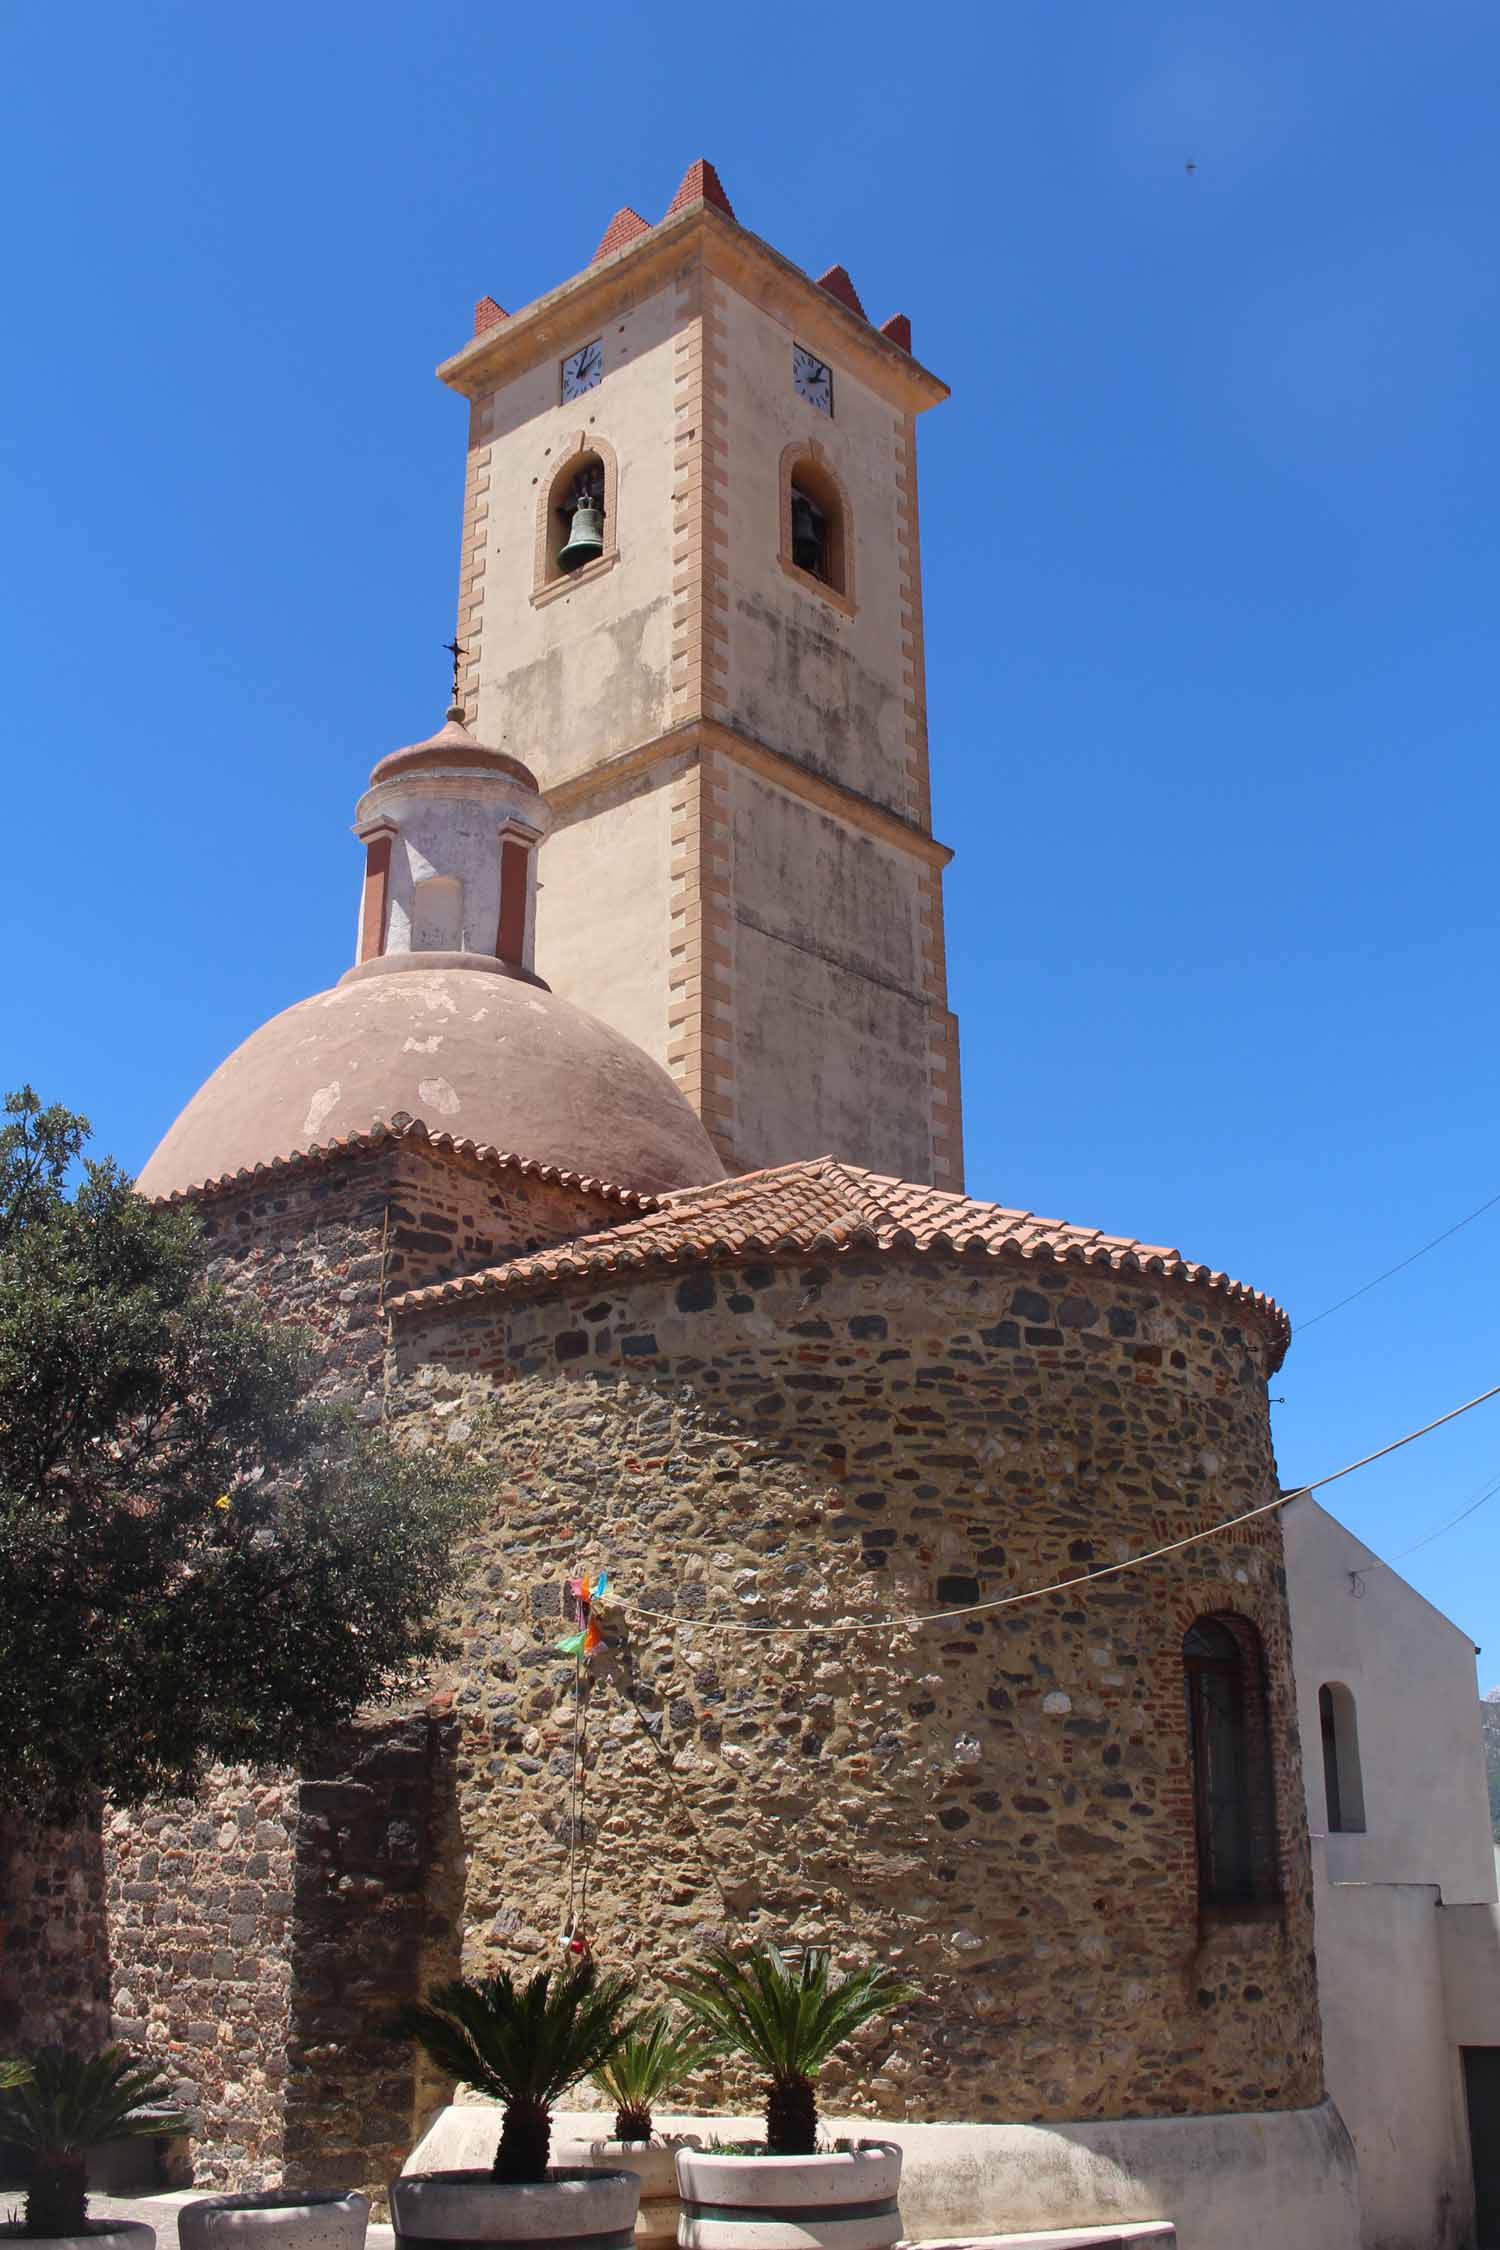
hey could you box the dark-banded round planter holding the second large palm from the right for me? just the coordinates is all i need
[391,2169,641,2250]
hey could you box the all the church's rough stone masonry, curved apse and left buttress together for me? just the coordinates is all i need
[0,1148,1322,2185]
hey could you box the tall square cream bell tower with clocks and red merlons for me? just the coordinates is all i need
[439,162,963,1188]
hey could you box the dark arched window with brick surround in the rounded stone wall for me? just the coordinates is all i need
[1183,1616,1277,1906]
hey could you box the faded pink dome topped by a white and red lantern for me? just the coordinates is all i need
[137,707,724,1197]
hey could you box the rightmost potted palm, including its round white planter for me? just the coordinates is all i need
[672,1946,911,2250]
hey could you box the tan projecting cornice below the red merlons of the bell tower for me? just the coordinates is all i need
[439,203,949,414]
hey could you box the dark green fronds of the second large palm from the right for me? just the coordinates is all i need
[387,1960,636,2106]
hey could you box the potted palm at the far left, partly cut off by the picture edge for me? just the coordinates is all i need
[0,2048,189,2250]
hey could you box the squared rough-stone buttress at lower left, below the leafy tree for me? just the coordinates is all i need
[106,1712,454,2187]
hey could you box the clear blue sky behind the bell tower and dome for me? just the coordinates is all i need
[0,0,1500,1688]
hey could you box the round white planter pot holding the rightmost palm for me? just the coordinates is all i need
[677,2140,902,2250]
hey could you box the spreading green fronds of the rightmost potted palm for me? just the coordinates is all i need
[672,1946,911,2079]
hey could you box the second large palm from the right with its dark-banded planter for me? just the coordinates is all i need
[389,1958,641,2250]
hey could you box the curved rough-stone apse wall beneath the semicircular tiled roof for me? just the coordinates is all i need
[391,1256,1320,2120]
